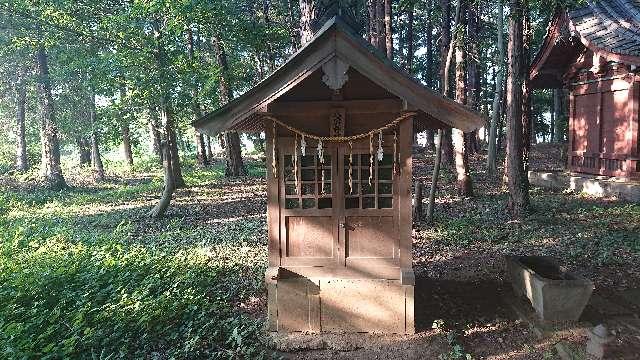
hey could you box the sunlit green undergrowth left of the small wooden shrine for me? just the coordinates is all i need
[0,165,271,359]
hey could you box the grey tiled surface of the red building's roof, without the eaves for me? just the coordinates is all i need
[569,0,640,56]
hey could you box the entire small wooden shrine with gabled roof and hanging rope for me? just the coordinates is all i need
[194,5,484,334]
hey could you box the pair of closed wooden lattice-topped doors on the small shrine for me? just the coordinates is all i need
[280,136,399,276]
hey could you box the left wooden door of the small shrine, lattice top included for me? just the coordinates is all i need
[279,138,340,266]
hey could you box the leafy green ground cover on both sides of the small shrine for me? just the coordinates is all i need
[0,153,640,359]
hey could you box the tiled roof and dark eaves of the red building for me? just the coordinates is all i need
[530,0,640,88]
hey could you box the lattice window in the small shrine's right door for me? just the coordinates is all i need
[344,153,393,209]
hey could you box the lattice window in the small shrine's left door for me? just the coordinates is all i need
[284,155,333,209]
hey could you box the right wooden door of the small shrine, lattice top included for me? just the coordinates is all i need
[338,136,399,275]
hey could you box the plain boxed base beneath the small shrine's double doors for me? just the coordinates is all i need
[266,269,415,334]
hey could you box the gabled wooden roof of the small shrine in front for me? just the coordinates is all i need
[193,16,484,134]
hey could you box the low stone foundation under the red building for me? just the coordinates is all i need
[529,171,640,203]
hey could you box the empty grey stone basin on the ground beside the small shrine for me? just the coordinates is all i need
[505,256,594,321]
